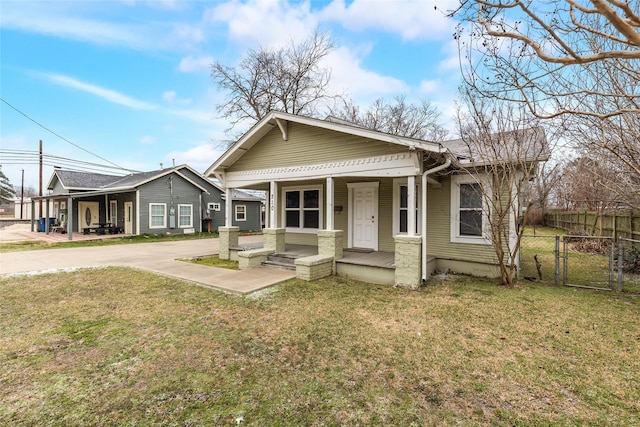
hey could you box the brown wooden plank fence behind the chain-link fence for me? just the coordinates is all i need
[544,210,640,240]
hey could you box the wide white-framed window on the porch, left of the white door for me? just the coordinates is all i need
[282,186,322,233]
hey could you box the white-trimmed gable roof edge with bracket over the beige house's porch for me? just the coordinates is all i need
[204,111,444,176]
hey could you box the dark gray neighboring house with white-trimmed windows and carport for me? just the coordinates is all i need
[32,165,262,240]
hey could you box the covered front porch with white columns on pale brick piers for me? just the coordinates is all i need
[220,170,442,288]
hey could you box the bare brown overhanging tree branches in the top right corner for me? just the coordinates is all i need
[450,0,640,119]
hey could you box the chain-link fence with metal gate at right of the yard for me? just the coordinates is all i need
[519,235,640,293]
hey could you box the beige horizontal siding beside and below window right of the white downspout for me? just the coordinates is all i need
[427,177,496,264]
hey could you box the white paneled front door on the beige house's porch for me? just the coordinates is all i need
[350,183,378,250]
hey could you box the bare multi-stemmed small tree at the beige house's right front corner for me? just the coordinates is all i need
[457,89,550,286]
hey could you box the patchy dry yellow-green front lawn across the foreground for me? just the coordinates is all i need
[0,268,640,426]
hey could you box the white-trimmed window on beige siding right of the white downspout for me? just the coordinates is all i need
[451,175,491,245]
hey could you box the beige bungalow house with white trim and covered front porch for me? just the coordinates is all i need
[205,112,546,287]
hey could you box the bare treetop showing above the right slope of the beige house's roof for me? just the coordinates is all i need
[331,96,447,141]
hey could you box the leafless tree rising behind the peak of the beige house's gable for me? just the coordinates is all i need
[211,32,332,134]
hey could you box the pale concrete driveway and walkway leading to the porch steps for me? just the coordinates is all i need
[0,236,295,295]
